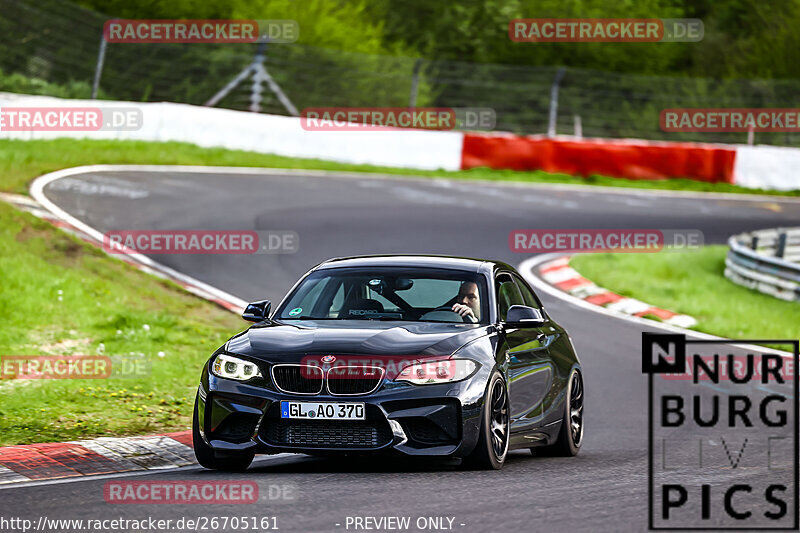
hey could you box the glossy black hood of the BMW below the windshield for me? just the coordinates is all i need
[227,320,493,362]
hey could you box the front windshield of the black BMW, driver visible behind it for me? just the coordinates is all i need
[275,268,488,323]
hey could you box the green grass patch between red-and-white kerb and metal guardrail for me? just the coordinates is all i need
[570,246,800,340]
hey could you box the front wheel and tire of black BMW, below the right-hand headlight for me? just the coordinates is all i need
[464,371,510,470]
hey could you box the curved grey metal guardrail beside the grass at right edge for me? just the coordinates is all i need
[725,228,800,301]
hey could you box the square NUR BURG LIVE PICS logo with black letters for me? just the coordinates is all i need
[642,333,800,530]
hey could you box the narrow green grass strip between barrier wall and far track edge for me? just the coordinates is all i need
[0,139,800,196]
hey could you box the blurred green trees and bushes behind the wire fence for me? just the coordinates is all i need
[0,0,800,146]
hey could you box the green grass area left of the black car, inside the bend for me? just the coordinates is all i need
[0,202,244,445]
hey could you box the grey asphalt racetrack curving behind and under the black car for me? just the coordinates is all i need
[6,171,800,532]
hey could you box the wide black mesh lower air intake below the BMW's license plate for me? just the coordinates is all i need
[262,420,392,448]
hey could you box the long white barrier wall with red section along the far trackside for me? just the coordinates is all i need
[0,94,800,190]
